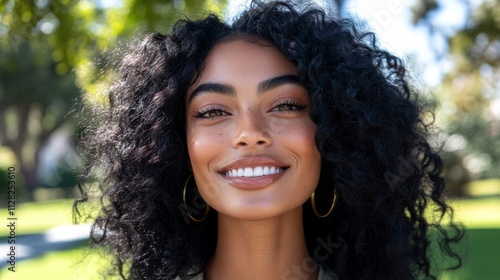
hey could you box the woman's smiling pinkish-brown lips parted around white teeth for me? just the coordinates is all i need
[219,156,289,190]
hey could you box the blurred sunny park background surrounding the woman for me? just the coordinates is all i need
[0,0,500,279]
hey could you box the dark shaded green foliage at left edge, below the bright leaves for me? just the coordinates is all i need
[0,38,79,112]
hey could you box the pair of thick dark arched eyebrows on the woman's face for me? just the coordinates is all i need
[188,74,302,103]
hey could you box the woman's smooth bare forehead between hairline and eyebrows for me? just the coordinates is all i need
[194,39,297,86]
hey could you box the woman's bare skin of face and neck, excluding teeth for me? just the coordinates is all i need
[186,39,321,280]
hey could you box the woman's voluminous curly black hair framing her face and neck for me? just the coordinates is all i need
[74,1,463,279]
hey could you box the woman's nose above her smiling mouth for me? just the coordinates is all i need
[233,110,272,148]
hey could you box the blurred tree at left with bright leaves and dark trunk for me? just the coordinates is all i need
[0,0,227,201]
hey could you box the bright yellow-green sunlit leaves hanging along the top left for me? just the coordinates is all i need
[0,0,227,88]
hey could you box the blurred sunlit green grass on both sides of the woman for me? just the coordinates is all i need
[0,196,500,280]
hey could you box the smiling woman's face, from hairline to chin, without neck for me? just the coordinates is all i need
[186,39,321,220]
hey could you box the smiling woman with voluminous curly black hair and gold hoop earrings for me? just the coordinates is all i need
[76,2,462,280]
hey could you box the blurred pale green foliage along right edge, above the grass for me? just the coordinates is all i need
[442,0,500,191]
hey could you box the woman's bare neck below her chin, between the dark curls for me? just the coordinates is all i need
[205,207,318,280]
